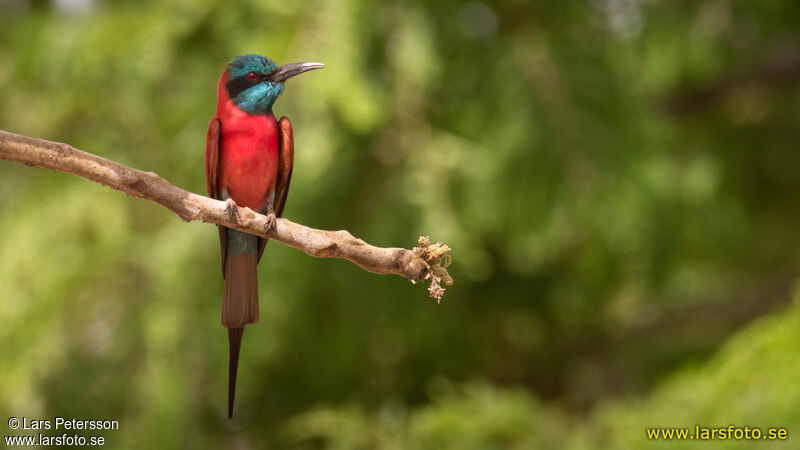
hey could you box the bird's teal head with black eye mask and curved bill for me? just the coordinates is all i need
[225,54,324,114]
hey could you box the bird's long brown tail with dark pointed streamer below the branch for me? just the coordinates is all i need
[222,229,258,418]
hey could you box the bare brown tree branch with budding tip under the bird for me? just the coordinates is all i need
[0,130,452,301]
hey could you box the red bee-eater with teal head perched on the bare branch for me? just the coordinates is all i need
[206,54,323,418]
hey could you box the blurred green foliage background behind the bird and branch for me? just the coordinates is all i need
[0,0,800,450]
